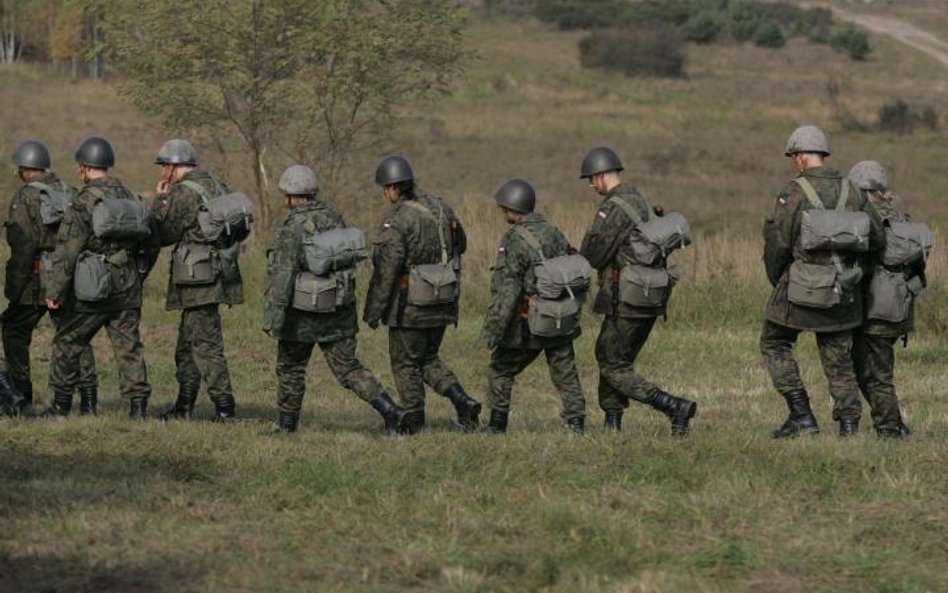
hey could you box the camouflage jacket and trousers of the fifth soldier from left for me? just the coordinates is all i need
[363,193,467,414]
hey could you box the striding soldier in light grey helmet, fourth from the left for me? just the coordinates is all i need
[263,165,405,433]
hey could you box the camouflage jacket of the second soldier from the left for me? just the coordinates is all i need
[44,177,158,313]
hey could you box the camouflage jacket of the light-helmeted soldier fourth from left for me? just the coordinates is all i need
[263,199,358,343]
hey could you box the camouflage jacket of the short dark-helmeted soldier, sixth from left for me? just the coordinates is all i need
[481,213,579,350]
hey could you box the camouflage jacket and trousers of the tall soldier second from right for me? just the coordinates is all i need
[760,167,882,421]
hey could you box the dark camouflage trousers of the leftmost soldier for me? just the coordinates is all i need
[0,303,98,388]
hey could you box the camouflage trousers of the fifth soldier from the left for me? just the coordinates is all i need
[388,326,458,412]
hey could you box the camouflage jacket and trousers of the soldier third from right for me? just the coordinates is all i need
[579,185,667,413]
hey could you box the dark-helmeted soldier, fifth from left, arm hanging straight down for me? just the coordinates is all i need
[363,155,481,433]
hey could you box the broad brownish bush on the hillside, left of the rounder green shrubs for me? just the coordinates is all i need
[579,25,685,78]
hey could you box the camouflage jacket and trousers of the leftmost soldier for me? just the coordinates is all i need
[2,171,98,405]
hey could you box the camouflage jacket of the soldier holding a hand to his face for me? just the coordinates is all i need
[152,169,244,310]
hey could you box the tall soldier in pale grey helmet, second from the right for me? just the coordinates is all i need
[760,126,881,439]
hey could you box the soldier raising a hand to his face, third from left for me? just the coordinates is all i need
[152,139,244,422]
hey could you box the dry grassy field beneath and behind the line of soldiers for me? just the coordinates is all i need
[0,2,948,593]
